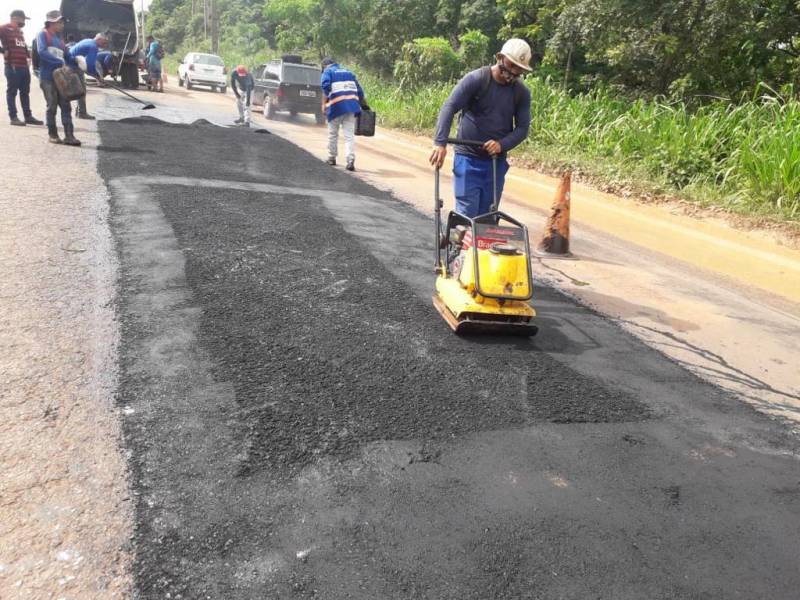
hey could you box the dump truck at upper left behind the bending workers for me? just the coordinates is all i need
[61,0,141,89]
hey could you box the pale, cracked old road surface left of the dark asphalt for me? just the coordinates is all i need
[0,80,132,600]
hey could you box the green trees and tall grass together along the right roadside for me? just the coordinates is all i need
[148,0,800,222]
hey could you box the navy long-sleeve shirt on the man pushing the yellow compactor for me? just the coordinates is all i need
[433,69,531,159]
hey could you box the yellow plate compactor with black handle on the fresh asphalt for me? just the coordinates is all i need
[433,139,538,336]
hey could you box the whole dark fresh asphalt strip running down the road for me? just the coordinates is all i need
[98,119,800,600]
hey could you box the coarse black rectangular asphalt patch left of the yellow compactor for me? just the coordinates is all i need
[155,187,648,470]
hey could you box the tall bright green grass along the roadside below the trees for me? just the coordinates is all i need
[361,76,800,221]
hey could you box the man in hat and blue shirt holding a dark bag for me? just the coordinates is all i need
[36,10,81,146]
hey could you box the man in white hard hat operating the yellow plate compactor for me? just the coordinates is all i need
[430,39,531,217]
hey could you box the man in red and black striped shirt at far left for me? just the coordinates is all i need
[0,10,42,126]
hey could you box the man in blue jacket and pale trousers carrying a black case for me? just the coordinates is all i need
[321,58,364,171]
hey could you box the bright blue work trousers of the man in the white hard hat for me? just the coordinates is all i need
[453,154,508,218]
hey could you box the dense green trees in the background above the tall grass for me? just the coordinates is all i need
[148,0,800,100]
